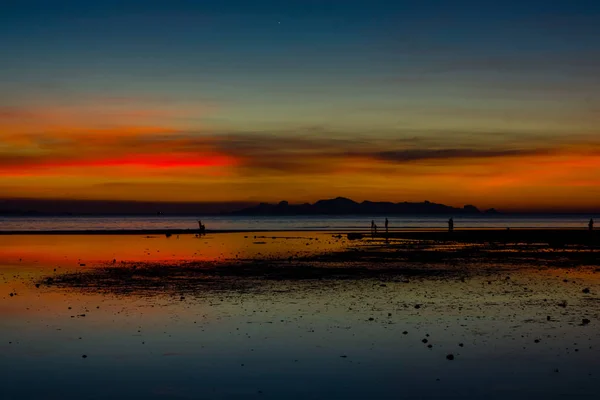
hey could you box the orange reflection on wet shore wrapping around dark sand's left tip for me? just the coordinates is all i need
[0,232,344,320]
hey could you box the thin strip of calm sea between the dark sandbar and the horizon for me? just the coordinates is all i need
[0,215,600,231]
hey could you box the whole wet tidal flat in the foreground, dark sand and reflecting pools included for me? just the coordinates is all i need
[0,232,600,399]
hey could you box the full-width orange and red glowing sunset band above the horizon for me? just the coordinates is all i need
[0,99,600,209]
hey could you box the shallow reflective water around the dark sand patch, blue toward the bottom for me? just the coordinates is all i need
[0,233,600,399]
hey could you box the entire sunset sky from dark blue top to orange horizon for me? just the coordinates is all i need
[0,0,600,211]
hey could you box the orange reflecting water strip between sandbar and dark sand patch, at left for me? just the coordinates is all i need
[0,233,340,268]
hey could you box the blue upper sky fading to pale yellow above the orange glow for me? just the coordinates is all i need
[0,0,600,135]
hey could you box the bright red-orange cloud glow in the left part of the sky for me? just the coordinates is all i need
[0,97,237,177]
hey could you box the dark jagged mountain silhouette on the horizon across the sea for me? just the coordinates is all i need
[224,197,488,215]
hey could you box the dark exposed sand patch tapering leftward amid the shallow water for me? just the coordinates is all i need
[38,230,600,293]
